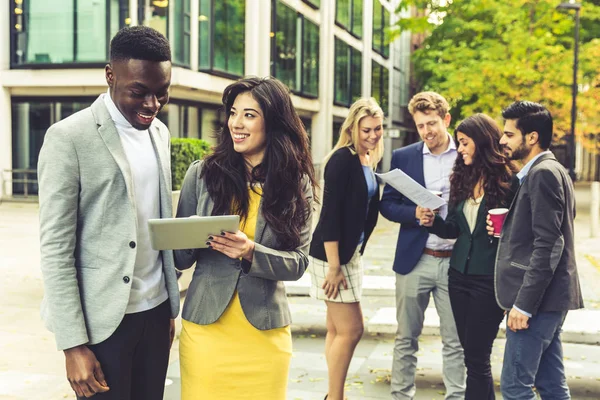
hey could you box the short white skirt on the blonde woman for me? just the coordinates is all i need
[308,244,364,303]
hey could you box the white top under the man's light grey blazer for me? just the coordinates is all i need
[104,92,169,314]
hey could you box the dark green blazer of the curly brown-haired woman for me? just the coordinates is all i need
[428,175,519,275]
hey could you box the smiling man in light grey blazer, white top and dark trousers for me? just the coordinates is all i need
[38,27,179,400]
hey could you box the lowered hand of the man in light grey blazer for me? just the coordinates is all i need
[64,345,110,397]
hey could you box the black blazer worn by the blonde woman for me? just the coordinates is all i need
[310,147,379,265]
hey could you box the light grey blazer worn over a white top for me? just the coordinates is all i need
[38,94,179,350]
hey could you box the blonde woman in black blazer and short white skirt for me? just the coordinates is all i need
[310,98,383,400]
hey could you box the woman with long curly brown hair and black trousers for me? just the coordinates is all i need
[421,114,518,400]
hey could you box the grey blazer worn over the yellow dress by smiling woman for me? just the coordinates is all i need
[174,161,312,330]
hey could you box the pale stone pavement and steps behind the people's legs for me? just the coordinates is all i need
[0,184,600,400]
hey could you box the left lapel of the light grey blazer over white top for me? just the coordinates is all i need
[92,96,135,204]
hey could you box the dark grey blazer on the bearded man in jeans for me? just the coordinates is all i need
[495,154,583,315]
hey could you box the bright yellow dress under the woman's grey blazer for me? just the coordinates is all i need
[179,190,292,400]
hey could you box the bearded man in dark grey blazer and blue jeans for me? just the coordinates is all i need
[488,101,583,400]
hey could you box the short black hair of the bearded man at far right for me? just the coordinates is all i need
[502,101,554,150]
